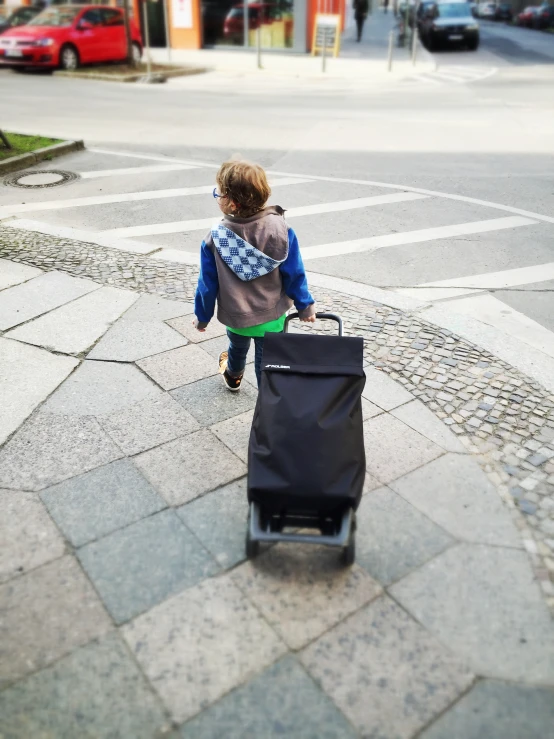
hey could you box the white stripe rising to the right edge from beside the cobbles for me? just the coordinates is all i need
[396,262,554,302]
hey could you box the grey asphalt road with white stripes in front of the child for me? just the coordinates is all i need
[0,19,554,355]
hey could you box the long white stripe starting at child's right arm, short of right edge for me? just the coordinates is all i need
[302,216,536,260]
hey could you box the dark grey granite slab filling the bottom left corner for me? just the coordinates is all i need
[0,634,169,739]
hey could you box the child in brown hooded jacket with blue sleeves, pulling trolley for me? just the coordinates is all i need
[194,160,315,392]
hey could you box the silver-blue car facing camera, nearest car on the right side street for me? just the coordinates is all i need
[420,0,479,51]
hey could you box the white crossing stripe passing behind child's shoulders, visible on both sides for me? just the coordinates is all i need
[101,192,426,239]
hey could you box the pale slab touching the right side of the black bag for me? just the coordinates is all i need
[364,414,444,484]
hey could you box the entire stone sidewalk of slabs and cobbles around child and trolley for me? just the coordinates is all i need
[0,251,554,739]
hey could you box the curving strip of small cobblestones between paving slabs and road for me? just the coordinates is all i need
[0,227,554,611]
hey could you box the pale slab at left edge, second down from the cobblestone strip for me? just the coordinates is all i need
[0,267,100,331]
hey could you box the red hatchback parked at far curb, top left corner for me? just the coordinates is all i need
[0,5,142,69]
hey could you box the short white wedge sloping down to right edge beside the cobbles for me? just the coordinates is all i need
[442,295,554,357]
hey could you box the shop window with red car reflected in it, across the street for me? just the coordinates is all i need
[202,0,294,49]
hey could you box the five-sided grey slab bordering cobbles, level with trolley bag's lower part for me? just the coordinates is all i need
[391,454,522,547]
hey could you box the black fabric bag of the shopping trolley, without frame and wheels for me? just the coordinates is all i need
[248,333,365,514]
